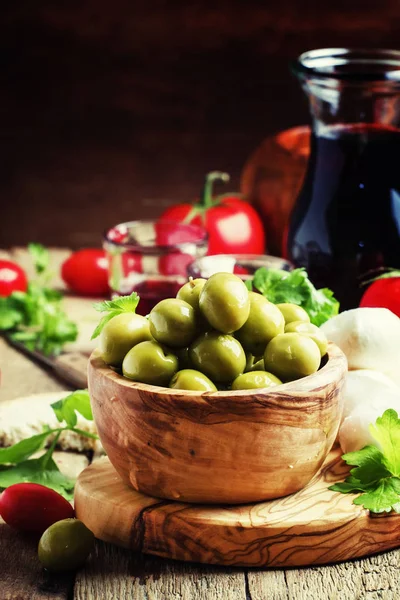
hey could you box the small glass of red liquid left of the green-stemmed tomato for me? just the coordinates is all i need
[103,220,207,315]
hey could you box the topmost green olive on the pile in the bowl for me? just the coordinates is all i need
[199,273,250,333]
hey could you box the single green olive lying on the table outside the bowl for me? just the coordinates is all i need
[38,519,94,571]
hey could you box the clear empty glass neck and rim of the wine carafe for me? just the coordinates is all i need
[293,48,400,135]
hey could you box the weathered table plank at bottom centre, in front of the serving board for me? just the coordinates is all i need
[74,543,245,600]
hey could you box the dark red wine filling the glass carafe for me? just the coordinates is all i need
[288,124,400,310]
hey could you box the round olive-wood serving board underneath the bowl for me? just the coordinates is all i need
[75,449,400,567]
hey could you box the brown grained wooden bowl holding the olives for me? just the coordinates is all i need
[88,344,347,504]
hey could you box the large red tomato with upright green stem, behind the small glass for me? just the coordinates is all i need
[160,172,265,254]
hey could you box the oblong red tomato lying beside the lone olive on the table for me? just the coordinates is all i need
[0,483,74,534]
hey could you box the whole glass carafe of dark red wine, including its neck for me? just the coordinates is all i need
[286,49,400,310]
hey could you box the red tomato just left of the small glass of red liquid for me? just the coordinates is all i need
[61,248,109,296]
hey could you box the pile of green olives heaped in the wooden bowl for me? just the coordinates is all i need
[100,273,328,392]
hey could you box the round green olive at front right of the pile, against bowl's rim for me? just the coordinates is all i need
[264,333,321,381]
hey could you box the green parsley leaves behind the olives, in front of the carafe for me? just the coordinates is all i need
[253,267,339,327]
